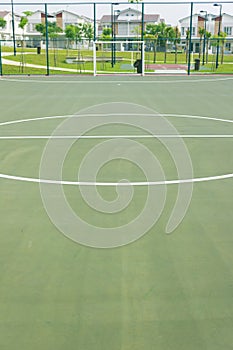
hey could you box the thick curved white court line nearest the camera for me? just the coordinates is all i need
[0,173,233,186]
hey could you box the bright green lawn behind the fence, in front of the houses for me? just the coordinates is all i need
[3,49,233,74]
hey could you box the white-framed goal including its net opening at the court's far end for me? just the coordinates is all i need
[93,40,145,75]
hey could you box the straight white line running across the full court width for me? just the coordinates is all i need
[0,134,233,140]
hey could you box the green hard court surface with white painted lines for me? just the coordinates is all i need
[0,76,233,350]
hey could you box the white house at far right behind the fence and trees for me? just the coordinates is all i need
[179,13,233,53]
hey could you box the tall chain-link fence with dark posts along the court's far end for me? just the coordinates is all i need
[0,2,233,75]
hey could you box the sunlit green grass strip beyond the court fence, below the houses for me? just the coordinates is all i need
[3,47,233,75]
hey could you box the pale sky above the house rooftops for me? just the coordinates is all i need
[0,0,233,26]
